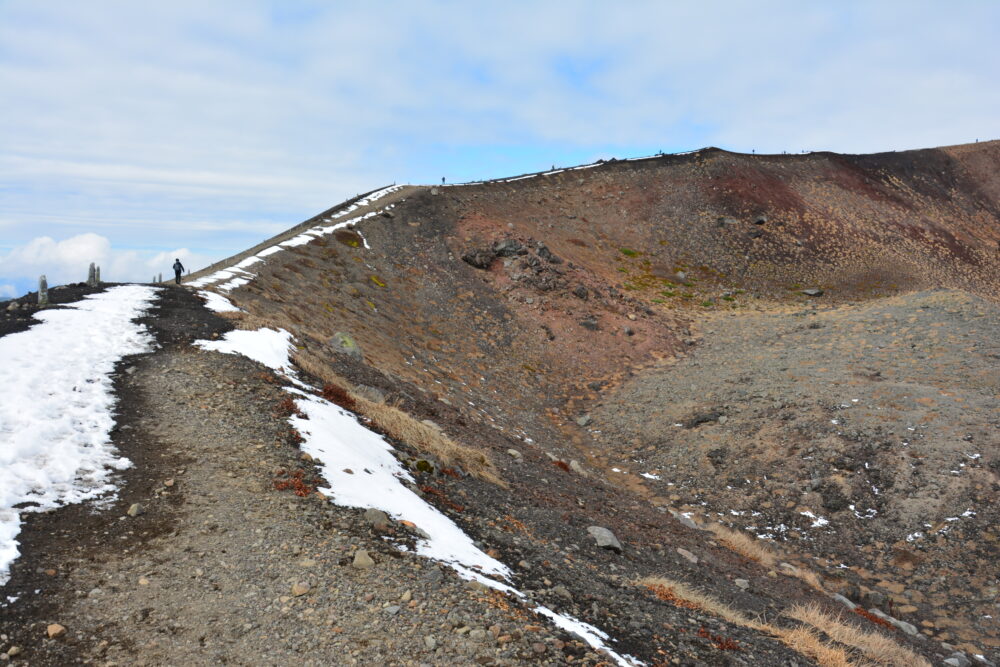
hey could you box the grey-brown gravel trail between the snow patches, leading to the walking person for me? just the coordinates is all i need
[0,289,598,665]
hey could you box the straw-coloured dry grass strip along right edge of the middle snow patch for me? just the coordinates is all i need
[293,350,507,486]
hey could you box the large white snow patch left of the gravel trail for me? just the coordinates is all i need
[0,285,157,584]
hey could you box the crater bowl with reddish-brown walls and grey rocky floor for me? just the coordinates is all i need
[186,142,1000,654]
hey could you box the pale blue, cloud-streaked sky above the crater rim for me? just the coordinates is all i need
[0,0,1000,298]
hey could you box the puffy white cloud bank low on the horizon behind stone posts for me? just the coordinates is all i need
[0,233,212,288]
